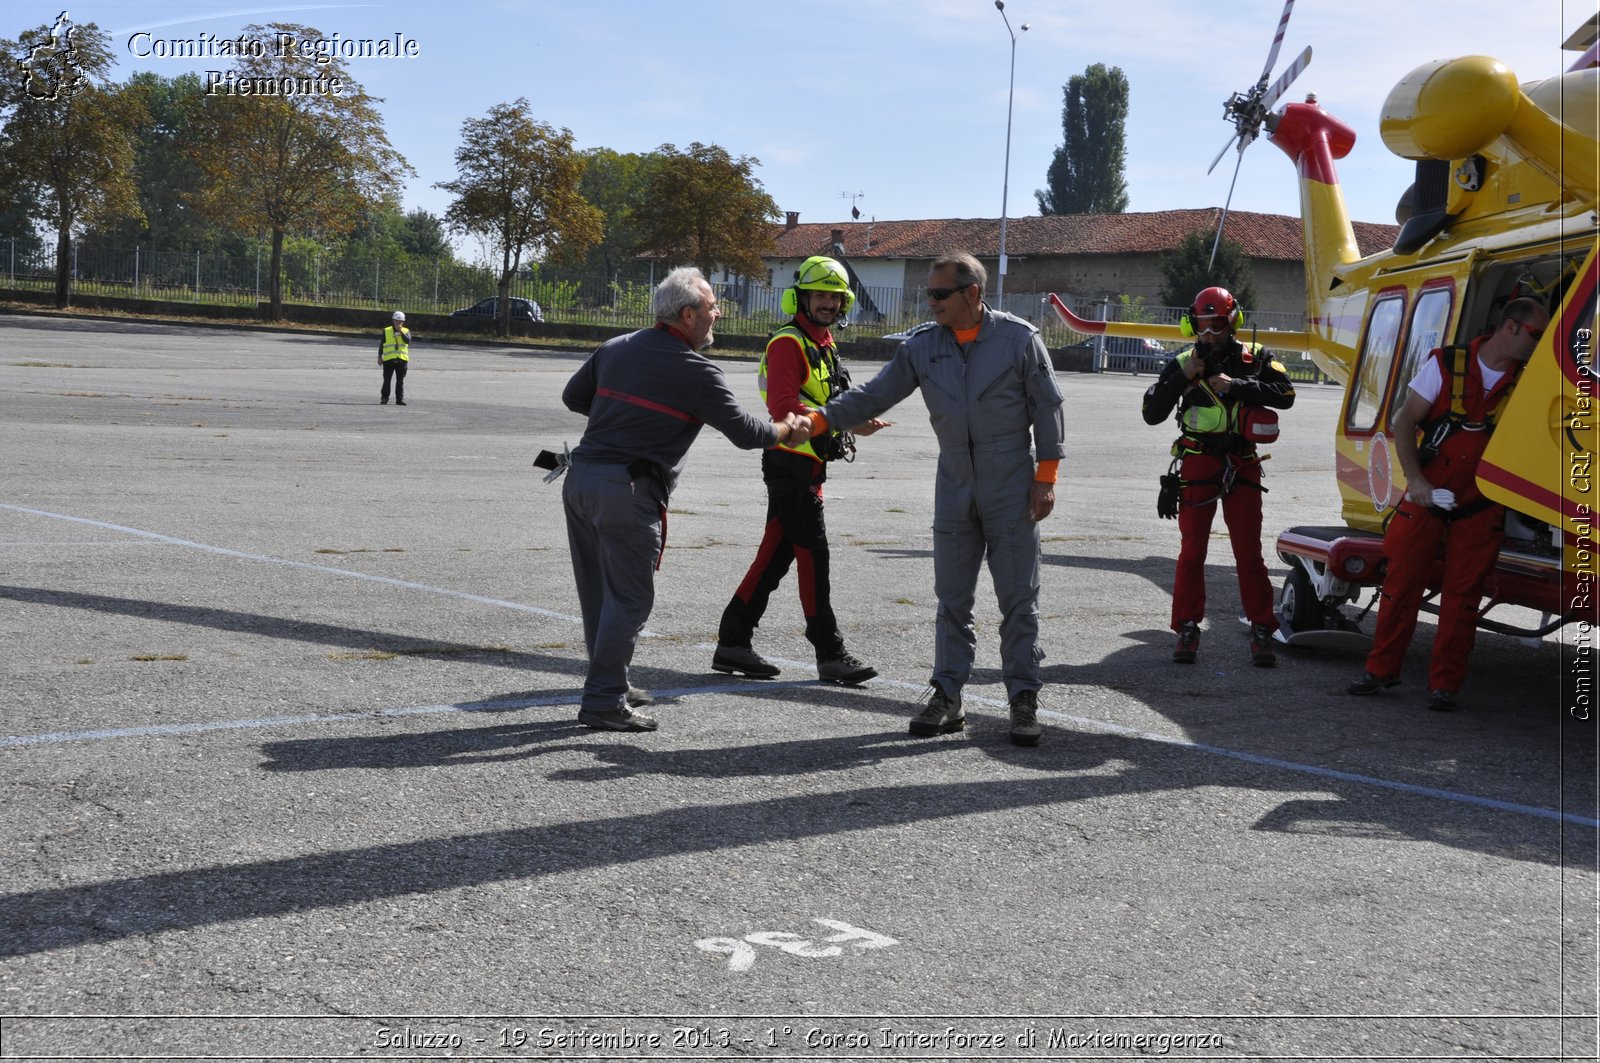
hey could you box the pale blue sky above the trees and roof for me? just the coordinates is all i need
[0,0,1595,257]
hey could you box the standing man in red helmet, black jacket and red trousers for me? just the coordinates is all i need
[1142,287,1294,668]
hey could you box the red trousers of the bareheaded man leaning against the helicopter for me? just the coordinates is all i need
[1366,501,1506,693]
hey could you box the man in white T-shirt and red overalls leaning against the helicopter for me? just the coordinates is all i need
[1349,298,1550,712]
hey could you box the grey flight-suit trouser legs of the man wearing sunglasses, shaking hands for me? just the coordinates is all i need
[933,506,1045,698]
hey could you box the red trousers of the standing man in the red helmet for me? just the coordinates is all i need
[1173,455,1277,631]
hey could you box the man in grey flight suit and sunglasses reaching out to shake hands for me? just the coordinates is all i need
[800,253,1066,746]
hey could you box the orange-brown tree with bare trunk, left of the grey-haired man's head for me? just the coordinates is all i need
[435,98,603,336]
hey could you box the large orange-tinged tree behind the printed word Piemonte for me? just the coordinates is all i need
[190,22,414,319]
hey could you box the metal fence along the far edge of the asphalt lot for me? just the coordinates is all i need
[0,240,1309,370]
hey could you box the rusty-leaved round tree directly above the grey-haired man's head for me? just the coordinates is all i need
[634,142,779,277]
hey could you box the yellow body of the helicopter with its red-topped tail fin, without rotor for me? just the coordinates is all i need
[1272,56,1600,605]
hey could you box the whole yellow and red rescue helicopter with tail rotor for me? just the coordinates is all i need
[1050,0,1600,650]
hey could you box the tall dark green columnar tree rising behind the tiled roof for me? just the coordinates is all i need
[1034,62,1128,215]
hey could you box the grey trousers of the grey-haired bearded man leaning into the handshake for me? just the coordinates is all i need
[562,463,666,712]
